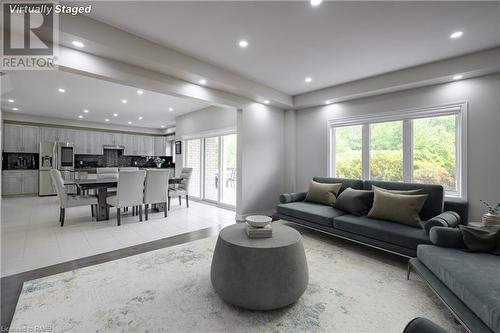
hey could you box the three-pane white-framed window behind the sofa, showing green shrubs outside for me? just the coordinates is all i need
[329,103,467,197]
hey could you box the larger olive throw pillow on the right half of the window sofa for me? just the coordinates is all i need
[368,187,428,228]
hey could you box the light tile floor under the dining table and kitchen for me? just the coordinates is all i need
[0,197,235,277]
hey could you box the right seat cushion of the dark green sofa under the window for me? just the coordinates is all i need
[333,215,431,249]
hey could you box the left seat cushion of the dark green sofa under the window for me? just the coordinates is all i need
[276,201,346,227]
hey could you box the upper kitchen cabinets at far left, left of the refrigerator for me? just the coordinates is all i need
[3,124,40,153]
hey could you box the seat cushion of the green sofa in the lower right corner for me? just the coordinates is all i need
[417,245,500,332]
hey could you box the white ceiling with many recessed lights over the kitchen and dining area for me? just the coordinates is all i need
[1,71,209,129]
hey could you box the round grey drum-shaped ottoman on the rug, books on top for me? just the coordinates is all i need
[210,223,309,310]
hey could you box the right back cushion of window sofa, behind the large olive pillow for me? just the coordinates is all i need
[364,180,444,221]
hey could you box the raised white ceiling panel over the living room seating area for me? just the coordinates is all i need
[82,1,500,95]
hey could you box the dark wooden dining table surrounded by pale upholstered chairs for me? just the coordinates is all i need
[64,175,183,221]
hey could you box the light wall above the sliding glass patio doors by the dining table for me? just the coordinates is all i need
[174,106,236,174]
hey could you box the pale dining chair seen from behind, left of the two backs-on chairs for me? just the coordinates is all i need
[106,170,146,225]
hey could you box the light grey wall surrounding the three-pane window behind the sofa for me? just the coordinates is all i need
[295,74,500,221]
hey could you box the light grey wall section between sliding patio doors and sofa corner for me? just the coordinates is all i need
[236,103,285,219]
